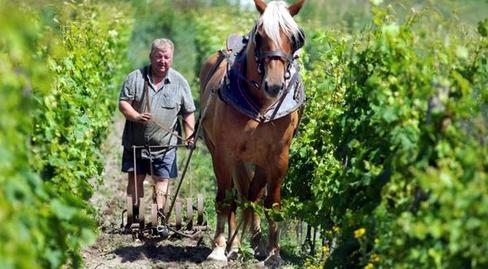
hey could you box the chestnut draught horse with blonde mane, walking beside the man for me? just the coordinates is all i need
[200,0,304,265]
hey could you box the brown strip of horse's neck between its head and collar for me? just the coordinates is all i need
[243,45,272,113]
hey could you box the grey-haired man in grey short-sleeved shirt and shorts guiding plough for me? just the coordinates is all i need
[119,38,195,214]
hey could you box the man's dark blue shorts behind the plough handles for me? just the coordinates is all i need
[122,147,178,178]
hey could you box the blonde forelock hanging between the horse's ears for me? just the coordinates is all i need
[258,1,302,46]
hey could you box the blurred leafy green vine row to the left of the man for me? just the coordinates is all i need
[0,1,131,268]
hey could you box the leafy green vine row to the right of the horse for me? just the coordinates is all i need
[285,1,488,268]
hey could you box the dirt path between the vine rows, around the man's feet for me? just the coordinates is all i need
[83,116,247,268]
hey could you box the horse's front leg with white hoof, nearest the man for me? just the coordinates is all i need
[207,154,232,262]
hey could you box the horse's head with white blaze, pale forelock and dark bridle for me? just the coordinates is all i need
[251,0,305,99]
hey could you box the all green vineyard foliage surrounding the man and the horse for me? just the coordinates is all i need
[0,0,488,268]
